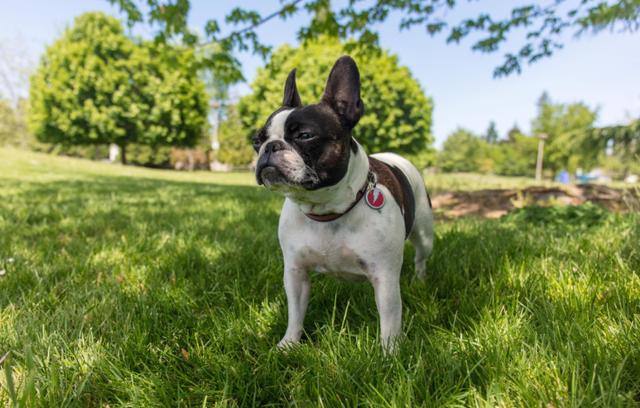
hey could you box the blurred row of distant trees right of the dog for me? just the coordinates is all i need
[436,93,640,178]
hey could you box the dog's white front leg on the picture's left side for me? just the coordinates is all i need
[278,267,311,348]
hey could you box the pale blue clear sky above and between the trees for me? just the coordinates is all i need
[0,0,640,146]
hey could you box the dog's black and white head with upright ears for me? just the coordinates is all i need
[253,56,364,191]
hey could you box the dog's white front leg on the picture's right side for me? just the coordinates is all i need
[371,274,402,353]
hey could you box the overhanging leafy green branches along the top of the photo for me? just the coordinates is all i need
[108,0,640,81]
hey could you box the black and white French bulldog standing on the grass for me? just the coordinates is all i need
[253,56,433,351]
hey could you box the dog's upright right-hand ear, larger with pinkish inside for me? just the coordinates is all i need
[322,55,364,129]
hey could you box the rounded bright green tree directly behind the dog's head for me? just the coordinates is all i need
[238,37,433,158]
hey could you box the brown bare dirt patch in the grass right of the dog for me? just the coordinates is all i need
[431,184,640,218]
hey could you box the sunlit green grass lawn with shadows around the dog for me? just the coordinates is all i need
[0,149,640,407]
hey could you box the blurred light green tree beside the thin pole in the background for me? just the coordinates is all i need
[531,93,598,172]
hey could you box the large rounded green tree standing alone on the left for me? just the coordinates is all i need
[29,13,207,163]
